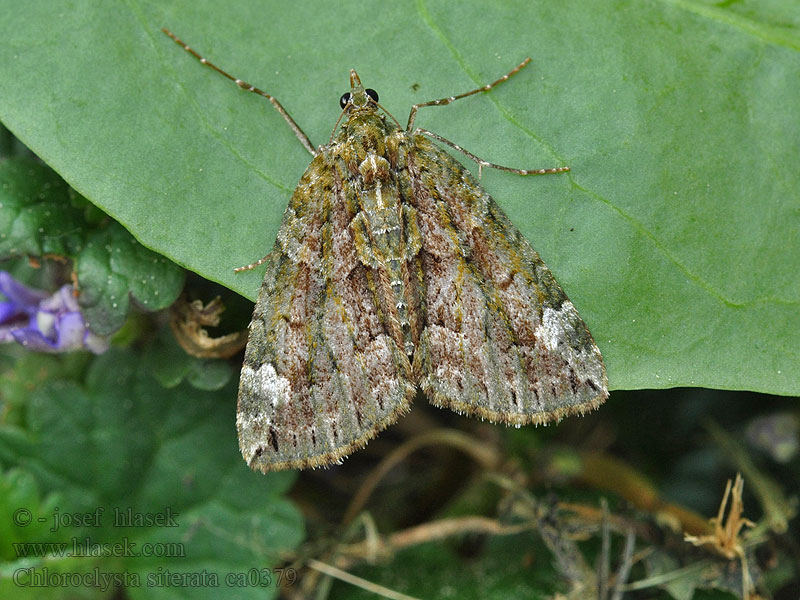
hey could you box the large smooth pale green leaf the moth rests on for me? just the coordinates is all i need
[0,0,800,394]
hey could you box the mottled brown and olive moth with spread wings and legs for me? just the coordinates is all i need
[164,29,608,472]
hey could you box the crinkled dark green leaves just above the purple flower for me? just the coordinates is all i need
[0,158,184,335]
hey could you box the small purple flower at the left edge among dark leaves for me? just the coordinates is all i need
[0,271,108,354]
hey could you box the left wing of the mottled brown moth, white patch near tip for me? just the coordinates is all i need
[236,154,416,471]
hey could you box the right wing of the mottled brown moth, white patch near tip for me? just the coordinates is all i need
[408,135,608,424]
